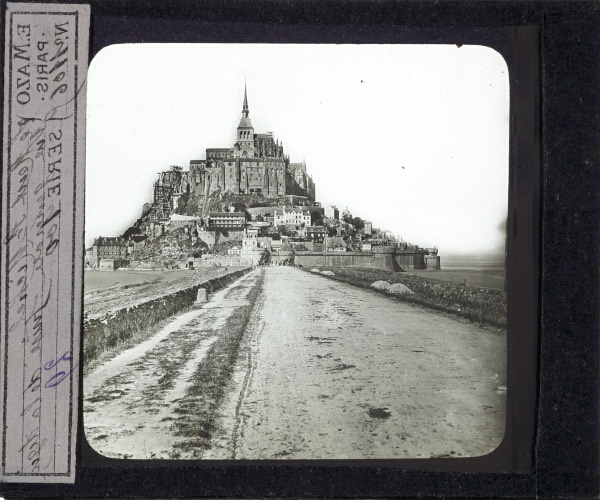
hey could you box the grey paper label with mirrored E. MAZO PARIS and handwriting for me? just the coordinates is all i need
[0,3,89,482]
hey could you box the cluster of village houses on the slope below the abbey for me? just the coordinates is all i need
[85,196,426,270]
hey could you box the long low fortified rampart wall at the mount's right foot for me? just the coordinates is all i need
[294,247,426,272]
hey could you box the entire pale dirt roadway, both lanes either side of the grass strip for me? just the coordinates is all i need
[84,267,506,459]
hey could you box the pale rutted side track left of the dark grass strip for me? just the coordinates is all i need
[84,272,259,459]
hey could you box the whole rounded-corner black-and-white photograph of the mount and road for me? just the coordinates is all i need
[82,44,510,463]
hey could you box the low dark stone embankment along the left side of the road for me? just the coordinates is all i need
[83,267,252,362]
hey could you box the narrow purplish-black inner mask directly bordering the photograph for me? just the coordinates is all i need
[81,20,541,472]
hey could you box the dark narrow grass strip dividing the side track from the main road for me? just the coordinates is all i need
[168,274,263,459]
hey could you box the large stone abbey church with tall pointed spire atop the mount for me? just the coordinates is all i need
[188,87,315,201]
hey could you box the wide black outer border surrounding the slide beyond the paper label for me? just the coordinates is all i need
[0,0,600,498]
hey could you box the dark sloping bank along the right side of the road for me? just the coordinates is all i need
[307,266,506,328]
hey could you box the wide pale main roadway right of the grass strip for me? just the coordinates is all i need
[204,267,506,459]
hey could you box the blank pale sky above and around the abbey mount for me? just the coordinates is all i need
[86,44,509,256]
